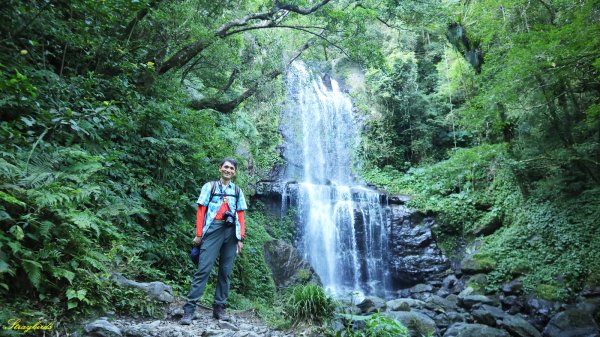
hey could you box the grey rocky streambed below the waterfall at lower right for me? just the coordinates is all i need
[340,275,600,337]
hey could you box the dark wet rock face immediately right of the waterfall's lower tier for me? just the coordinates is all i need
[389,205,450,287]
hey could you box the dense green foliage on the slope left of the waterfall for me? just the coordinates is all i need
[0,1,300,327]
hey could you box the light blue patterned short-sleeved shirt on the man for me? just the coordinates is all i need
[196,181,248,240]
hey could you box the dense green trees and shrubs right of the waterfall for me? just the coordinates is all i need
[359,0,600,299]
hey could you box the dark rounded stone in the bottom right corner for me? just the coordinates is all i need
[544,309,600,337]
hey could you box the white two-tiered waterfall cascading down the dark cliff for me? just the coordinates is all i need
[281,62,390,295]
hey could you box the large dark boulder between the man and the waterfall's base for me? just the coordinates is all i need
[264,240,321,288]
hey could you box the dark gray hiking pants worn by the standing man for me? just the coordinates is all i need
[183,221,237,313]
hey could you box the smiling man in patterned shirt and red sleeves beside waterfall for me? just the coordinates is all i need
[180,158,248,325]
